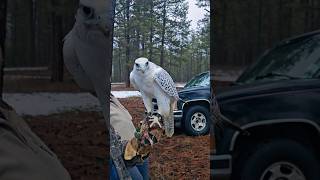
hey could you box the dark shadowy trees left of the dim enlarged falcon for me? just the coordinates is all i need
[6,0,78,67]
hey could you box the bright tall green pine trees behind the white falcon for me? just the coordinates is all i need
[113,0,209,82]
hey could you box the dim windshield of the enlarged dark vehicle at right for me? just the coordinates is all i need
[237,35,320,83]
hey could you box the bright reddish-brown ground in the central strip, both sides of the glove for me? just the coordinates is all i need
[120,98,210,180]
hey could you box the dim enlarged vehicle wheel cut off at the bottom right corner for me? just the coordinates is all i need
[233,139,320,180]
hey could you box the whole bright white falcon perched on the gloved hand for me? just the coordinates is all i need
[130,58,179,137]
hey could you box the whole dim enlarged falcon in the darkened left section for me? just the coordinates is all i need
[63,0,115,124]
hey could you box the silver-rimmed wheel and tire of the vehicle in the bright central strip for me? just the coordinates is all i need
[184,105,210,136]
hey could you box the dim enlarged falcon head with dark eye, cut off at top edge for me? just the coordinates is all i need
[76,0,113,35]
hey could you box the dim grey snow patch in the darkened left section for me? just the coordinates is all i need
[3,93,100,116]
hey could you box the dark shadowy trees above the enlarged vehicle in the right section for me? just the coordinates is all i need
[214,0,320,67]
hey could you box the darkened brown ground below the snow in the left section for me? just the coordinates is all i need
[24,111,108,180]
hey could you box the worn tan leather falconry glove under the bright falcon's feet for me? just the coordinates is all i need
[124,115,164,166]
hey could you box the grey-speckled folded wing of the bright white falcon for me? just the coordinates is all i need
[153,69,179,100]
